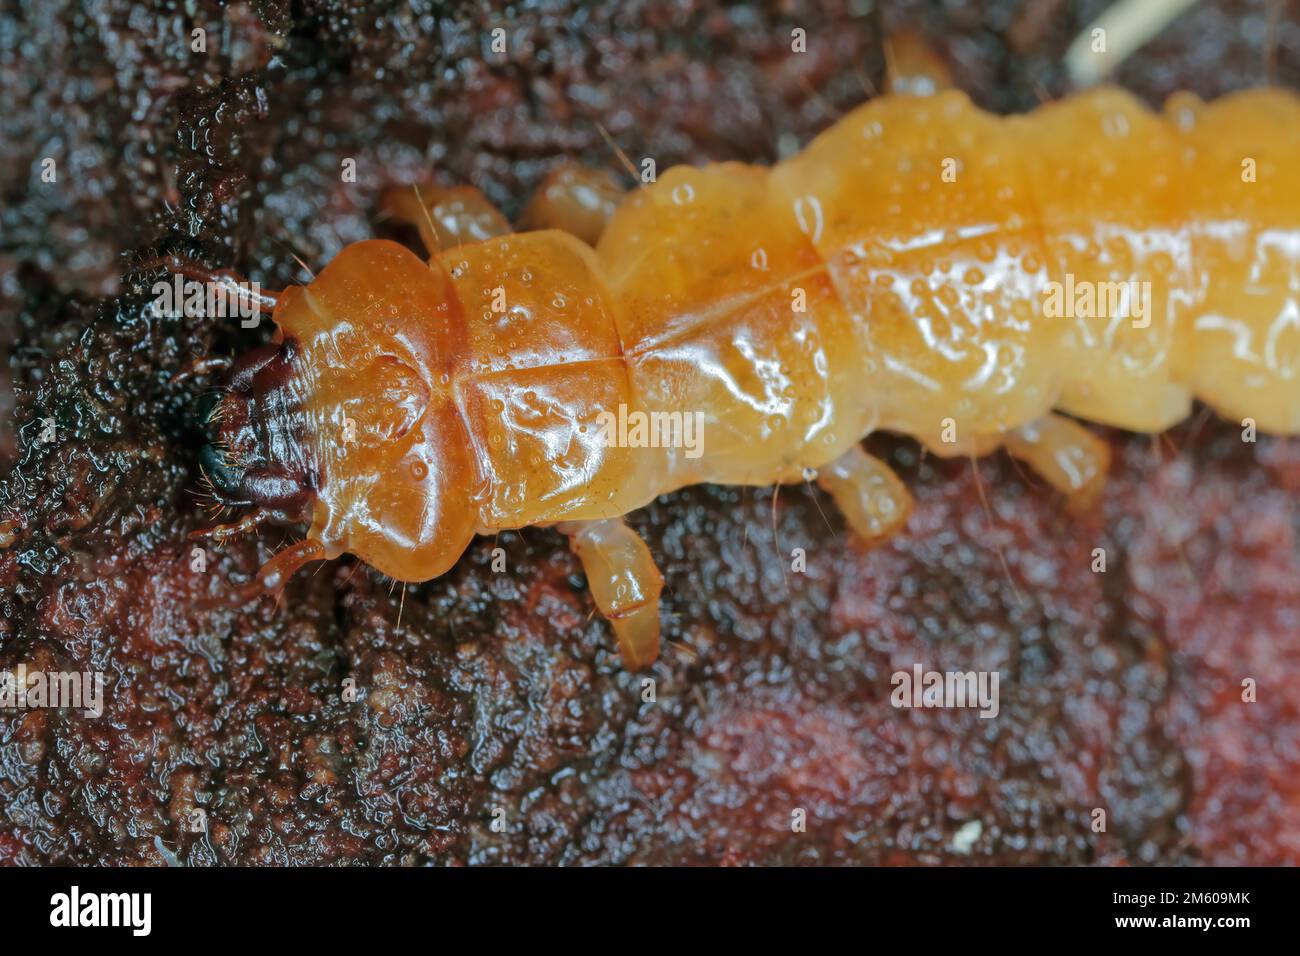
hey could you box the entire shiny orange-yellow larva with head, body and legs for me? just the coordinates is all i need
[195,80,1300,666]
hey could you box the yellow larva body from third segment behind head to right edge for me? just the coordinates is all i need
[774,90,1300,444]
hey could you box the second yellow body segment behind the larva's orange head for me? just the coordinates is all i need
[597,164,874,488]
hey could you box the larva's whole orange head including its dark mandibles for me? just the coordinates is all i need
[213,241,477,581]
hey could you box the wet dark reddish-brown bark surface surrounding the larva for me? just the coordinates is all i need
[0,0,1300,864]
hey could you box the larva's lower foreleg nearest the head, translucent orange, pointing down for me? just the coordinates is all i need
[556,518,663,670]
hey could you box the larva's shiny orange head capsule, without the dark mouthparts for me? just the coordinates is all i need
[269,242,480,576]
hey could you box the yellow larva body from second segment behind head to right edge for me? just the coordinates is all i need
[599,90,1300,481]
